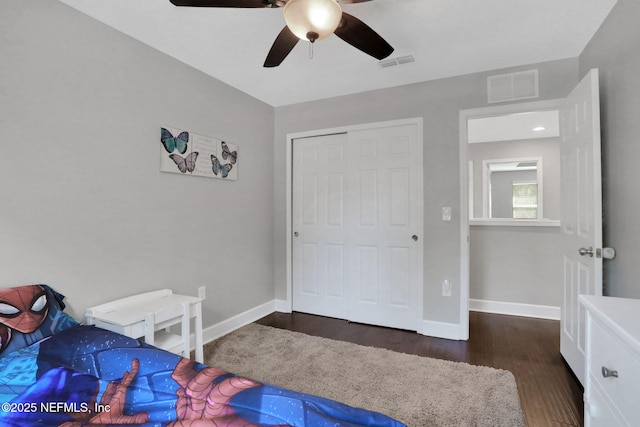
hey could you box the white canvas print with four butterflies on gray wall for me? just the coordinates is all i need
[160,126,238,181]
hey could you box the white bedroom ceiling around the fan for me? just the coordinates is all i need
[60,0,616,106]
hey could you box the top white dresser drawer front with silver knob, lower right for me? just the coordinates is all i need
[587,317,640,425]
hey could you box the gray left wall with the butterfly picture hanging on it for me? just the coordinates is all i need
[0,0,274,326]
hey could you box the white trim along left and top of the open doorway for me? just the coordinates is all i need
[459,99,562,340]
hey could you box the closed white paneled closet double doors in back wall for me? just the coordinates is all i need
[292,125,423,330]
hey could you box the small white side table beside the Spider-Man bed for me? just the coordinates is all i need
[85,288,204,363]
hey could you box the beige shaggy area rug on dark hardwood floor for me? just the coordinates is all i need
[204,324,524,427]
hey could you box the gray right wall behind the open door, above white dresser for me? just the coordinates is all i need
[579,0,640,298]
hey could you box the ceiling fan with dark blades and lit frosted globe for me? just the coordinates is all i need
[170,0,393,67]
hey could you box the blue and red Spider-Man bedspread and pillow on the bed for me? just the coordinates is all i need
[0,285,403,427]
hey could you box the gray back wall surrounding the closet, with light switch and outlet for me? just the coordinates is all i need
[274,58,578,323]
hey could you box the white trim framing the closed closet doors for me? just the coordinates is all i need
[279,117,426,331]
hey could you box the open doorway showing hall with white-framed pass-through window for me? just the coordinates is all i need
[460,100,562,338]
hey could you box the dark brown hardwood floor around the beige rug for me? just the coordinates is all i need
[257,312,583,427]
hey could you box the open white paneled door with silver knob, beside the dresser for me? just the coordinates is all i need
[560,70,602,383]
